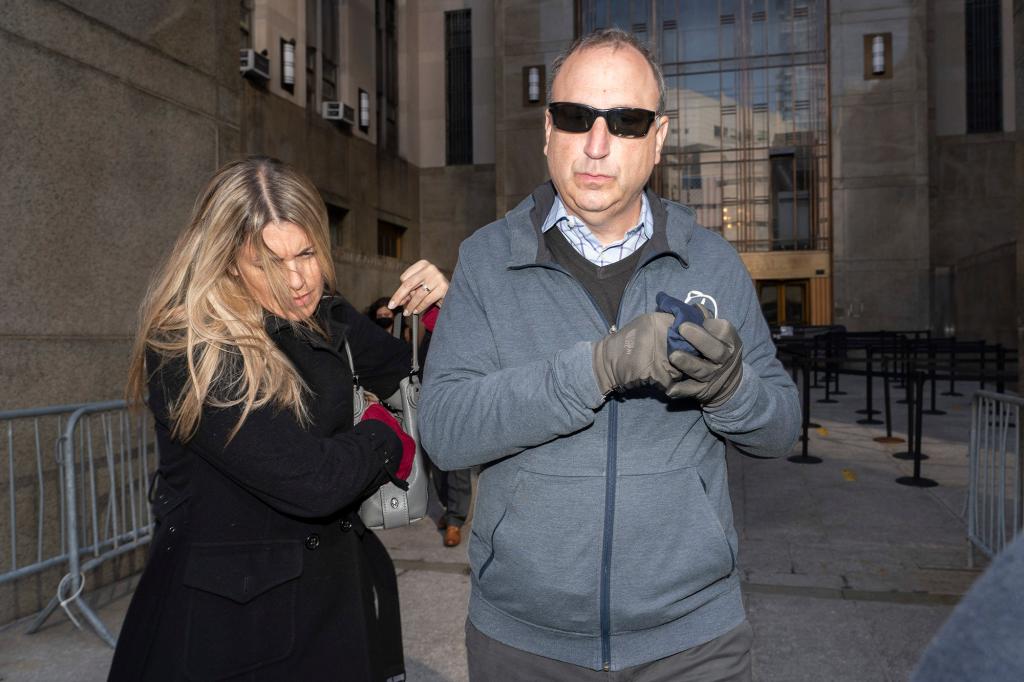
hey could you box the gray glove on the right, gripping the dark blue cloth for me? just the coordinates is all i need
[666,318,743,408]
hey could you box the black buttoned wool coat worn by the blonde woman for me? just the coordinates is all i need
[110,297,411,682]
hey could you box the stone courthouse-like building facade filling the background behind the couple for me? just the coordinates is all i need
[0,0,1024,622]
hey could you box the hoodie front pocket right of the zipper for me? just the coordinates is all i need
[611,467,736,632]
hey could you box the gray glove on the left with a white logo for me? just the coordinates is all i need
[594,312,681,395]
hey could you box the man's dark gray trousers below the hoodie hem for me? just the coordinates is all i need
[466,619,754,682]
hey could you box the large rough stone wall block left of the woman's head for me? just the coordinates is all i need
[0,34,218,335]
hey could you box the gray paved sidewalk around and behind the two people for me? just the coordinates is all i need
[0,378,980,682]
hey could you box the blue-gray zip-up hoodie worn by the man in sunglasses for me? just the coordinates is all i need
[420,183,800,671]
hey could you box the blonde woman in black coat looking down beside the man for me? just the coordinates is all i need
[110,158,447,682]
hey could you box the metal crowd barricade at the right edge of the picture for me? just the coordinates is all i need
[967,391,1024,567]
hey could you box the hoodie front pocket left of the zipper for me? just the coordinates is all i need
[474,471,604,634]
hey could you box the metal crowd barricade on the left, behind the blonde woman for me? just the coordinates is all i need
[0,400,157,646]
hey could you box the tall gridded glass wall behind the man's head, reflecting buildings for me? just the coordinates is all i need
[578,0,830,251]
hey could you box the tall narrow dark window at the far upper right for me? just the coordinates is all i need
[965,0,1002,133]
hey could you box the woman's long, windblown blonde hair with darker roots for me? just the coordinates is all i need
[127,157,335,440]
